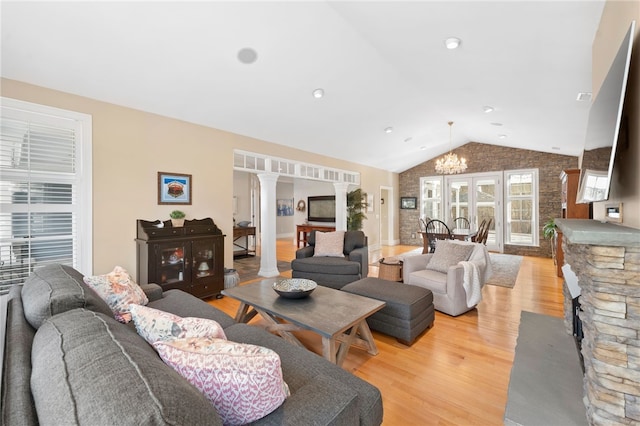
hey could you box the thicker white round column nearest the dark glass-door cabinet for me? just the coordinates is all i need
[258,173,280,277]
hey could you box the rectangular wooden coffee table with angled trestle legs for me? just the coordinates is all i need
[222,278,385,366]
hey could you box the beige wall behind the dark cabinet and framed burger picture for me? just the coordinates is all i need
[0,79,398,275]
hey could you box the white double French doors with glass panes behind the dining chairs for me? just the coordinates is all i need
[444,173,504,253]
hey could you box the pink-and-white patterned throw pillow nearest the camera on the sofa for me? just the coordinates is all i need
[153,337,289,425]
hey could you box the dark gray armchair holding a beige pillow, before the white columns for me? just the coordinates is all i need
[291,231,369,290]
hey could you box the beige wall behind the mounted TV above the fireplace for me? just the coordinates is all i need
[592,0,640,228]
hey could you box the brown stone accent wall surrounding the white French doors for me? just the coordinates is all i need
[399,142,578,257]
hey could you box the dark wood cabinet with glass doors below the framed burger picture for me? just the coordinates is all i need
[136,219,225,298]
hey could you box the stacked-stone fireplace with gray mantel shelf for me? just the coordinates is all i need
[556,219,640,425]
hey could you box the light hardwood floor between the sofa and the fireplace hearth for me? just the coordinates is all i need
[209,240,563,425]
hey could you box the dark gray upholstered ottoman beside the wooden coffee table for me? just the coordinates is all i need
[342,277,435,345]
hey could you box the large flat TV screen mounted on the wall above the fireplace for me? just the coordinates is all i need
[577,21,635,203]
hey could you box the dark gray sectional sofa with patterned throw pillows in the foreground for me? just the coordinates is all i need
[0,265,382,426]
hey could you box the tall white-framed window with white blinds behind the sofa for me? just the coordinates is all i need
[0,98,92,293]
